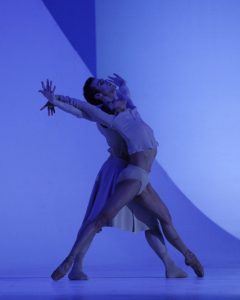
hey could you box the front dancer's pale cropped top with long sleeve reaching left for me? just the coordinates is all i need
[51,95,158,155]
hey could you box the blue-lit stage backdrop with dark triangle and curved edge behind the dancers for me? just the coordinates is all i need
[0,0,240,275]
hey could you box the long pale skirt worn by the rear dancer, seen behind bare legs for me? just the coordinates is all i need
[83,156,159,232]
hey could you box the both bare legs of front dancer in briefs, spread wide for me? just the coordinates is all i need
[52,180,203,280]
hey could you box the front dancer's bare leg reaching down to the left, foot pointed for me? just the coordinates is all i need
[51,179,141,280]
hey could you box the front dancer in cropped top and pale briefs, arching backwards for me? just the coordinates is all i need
[40,79,203,280]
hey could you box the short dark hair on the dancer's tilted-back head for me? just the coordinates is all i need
[83,77,113,114]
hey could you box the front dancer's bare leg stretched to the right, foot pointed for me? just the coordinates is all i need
[138,183,204,277]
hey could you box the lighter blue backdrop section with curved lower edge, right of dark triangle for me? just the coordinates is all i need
[96,0,240,238]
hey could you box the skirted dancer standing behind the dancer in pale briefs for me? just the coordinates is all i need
[42,94,187,280]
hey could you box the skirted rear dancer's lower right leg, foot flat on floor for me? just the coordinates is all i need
[145,228,188,278]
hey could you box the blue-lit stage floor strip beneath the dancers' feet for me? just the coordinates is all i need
[0,268,240,300]
